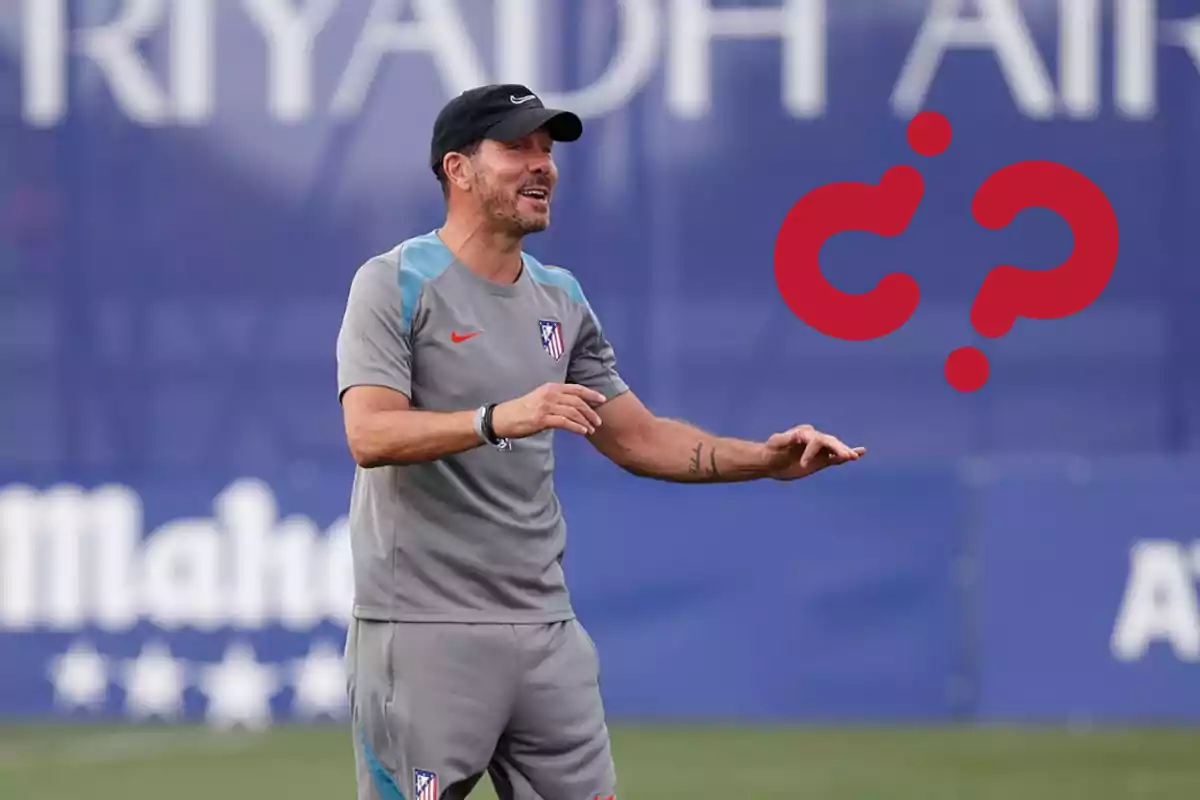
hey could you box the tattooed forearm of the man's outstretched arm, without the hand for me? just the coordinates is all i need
[609,417,767,483]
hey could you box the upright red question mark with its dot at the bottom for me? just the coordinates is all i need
[946,161,1120,392]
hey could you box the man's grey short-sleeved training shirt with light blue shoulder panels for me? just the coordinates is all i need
[337,231,628,622]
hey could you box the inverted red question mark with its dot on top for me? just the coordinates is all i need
[775,112,952,342]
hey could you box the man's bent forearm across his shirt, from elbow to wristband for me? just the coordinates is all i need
[348,410,482,468]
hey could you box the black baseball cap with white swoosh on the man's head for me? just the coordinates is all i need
[430,83,583,173]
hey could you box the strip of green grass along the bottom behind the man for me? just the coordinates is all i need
[0,726,1200,800]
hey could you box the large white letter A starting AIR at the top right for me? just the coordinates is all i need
[892,0,1055,119]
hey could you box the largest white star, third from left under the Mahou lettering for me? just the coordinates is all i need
[200,643,280,730]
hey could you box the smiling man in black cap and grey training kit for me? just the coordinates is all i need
[337,85,865,800]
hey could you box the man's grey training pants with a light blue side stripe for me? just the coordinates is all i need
[346,620,617,800]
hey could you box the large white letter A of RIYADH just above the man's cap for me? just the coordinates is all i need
[332,0,488,116]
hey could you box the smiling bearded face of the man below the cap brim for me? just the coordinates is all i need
[472,131,558,235]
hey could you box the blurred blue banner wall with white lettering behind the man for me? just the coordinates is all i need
[0,0,1200,724]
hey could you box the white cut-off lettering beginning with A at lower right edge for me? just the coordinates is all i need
[1111,541,1200,662]
